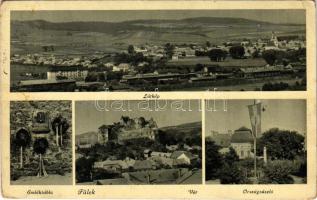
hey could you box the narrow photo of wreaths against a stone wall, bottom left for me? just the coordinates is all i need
[10,101,73,185]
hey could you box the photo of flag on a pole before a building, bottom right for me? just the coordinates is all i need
[205,99,307,184]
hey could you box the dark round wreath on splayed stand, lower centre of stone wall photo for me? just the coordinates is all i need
[33,138,49,177]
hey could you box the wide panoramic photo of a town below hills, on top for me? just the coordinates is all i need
[10,10,306,92]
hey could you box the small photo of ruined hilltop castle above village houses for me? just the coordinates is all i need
[75,100,202,185]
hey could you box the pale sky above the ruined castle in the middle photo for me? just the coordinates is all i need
[75,100,202,134]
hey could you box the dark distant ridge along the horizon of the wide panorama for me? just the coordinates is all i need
[11,17,302,34]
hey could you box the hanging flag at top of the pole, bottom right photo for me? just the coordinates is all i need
[248,102,262,138]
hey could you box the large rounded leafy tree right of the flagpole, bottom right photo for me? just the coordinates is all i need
[257,128,305,160]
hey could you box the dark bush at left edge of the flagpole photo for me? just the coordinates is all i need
[206,140,223,180]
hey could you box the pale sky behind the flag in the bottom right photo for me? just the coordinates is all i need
[205,99,306,136]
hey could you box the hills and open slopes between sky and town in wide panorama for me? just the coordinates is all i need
[11,17,305,54]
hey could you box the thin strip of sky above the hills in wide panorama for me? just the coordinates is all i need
[11,9,306,24]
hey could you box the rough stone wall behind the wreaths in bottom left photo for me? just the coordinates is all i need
[10,101,72,180]
